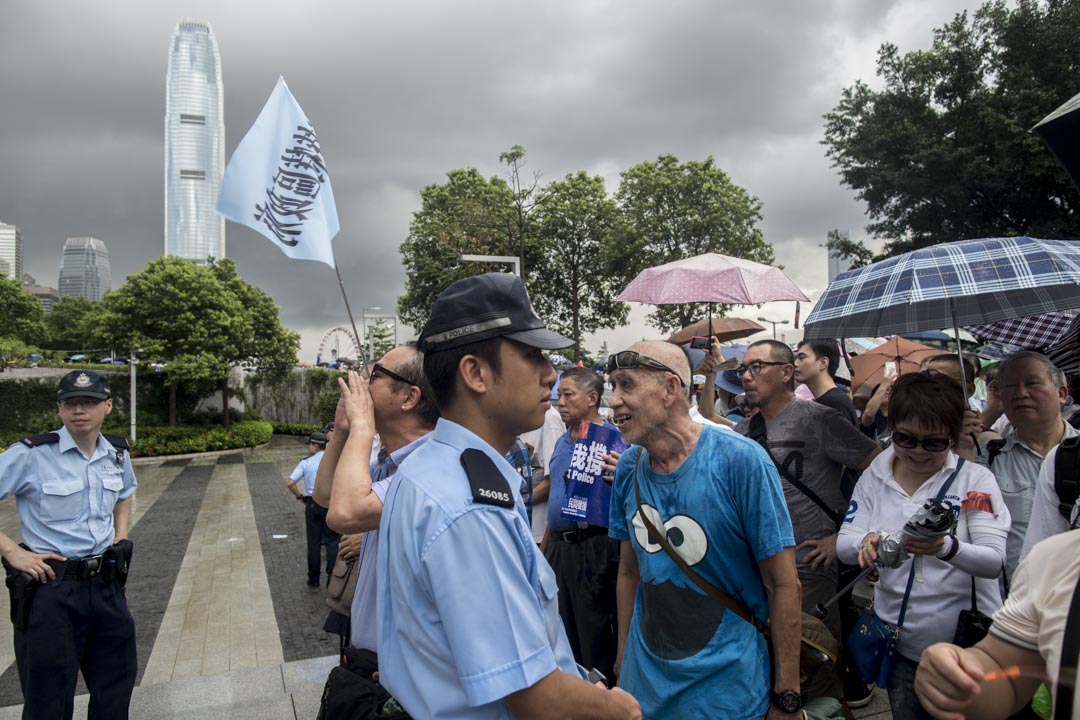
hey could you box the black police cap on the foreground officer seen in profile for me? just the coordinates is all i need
[417,272,573,353]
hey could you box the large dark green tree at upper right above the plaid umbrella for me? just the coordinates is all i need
[823,0,1080,263]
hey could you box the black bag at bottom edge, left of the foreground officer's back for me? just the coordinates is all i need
[316,648,409,720]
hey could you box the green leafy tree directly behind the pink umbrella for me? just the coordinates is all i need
[607,155,774,331]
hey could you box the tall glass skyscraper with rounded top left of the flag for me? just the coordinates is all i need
[165,22,225,263]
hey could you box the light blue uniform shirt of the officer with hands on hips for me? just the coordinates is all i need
[0,427,137,558]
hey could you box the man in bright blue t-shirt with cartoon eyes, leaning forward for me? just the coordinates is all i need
[607,341,801,720]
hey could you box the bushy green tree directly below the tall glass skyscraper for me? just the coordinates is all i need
[103,256,247,425]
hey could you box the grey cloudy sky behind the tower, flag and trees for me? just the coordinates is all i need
[0,0,978,361]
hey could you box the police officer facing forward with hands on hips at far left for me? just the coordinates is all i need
[0,370,137,718]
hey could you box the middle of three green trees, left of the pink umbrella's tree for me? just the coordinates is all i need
[528,172,629,361]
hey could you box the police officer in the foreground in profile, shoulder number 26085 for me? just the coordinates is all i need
[376,273,642,720]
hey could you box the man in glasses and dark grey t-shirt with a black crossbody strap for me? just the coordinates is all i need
[735,340,880,695]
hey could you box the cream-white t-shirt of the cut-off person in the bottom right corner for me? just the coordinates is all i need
[990,532,1080,718]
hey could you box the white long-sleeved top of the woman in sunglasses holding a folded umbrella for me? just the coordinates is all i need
[836,447,1010,661]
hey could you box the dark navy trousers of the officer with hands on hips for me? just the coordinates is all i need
[15,573,138,720]
